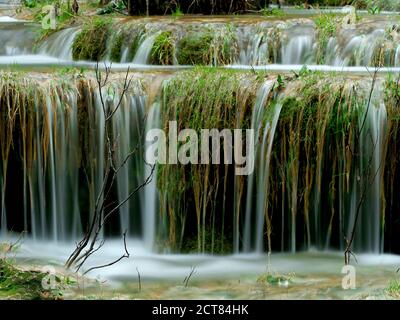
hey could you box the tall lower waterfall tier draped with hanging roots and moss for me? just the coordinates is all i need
[0,68,400,254]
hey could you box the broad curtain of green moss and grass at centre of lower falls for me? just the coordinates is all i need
[158,68,262,253]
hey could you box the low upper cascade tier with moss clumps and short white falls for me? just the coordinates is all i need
[0,14,400,67]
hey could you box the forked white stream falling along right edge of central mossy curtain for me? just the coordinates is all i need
[243,80,282,252]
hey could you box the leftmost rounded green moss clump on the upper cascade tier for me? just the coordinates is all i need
[72,18,111,61]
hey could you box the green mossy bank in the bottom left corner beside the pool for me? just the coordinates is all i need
[0,259,62,300]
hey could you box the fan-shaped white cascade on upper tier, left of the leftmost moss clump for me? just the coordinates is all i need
[38,28,79,61]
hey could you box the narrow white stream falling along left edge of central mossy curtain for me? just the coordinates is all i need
[142,102,161,250]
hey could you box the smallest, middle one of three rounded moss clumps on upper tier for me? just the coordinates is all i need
[151,31,175,65]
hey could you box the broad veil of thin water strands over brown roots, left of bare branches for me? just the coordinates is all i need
[24,89,81,241]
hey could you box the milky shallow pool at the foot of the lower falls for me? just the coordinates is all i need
[7,240,400,299]
